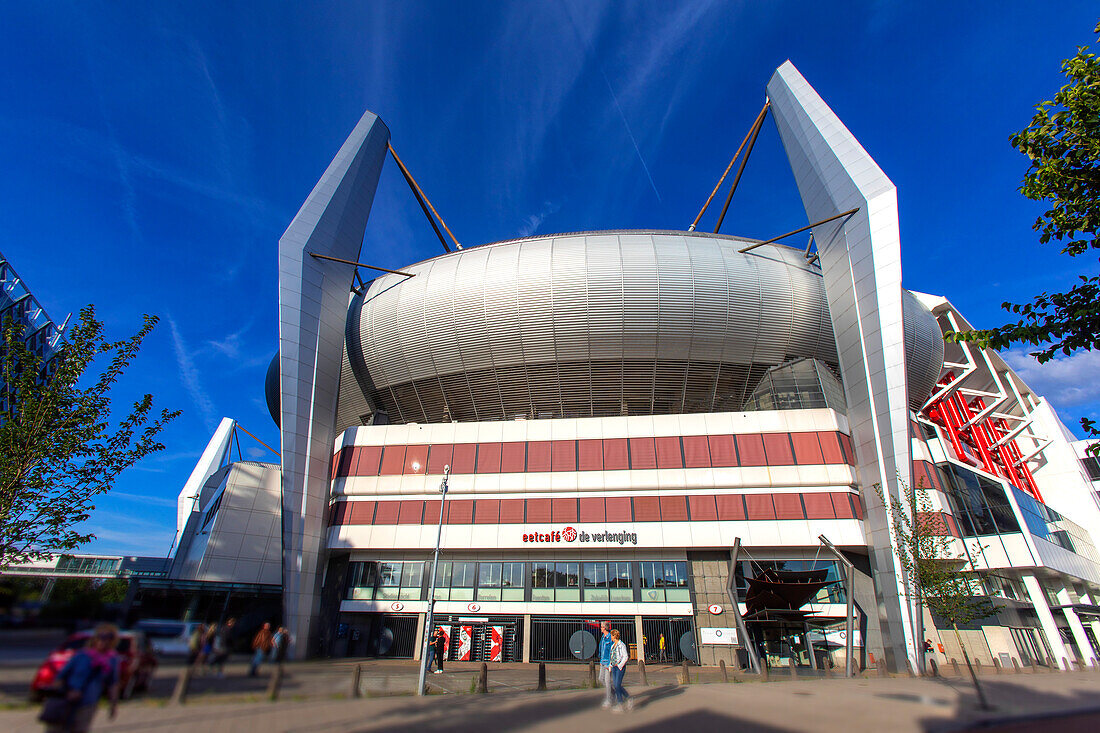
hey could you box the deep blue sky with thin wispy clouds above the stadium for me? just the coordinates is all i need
[0,0,1100,554]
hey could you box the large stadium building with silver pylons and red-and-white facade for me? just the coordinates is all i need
[165,63,1100,670]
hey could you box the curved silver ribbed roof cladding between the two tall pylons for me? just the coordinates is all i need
[338,231,837,422]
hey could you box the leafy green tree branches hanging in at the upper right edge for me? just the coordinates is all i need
[947,23,1100,436]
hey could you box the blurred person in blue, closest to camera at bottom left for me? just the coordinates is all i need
[39,624,119,733]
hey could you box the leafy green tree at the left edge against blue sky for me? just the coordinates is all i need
[0,306,179,568]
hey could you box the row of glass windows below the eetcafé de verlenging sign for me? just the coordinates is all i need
[347,560,691,603]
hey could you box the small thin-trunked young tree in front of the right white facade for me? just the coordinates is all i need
[875,482,997,710]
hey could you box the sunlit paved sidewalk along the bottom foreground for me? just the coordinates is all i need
[0,672,1100,733]
